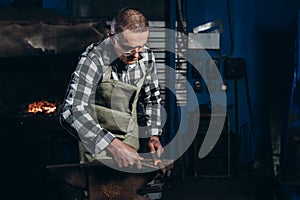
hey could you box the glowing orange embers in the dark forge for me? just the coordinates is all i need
[27,101,56,114]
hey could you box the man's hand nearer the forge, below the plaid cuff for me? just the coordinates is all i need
[107,138,144,169]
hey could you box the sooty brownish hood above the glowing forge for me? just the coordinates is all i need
[0,20,105,57]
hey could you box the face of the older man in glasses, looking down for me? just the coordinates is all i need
[114,30,149,65]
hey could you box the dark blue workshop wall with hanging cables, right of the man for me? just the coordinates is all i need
[186,0,300,173]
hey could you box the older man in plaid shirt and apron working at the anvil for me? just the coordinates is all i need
[60,8,163,169]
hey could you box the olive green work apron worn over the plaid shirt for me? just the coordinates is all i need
[79,60,146,163]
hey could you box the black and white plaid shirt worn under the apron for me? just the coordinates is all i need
[60,38,161,154]
